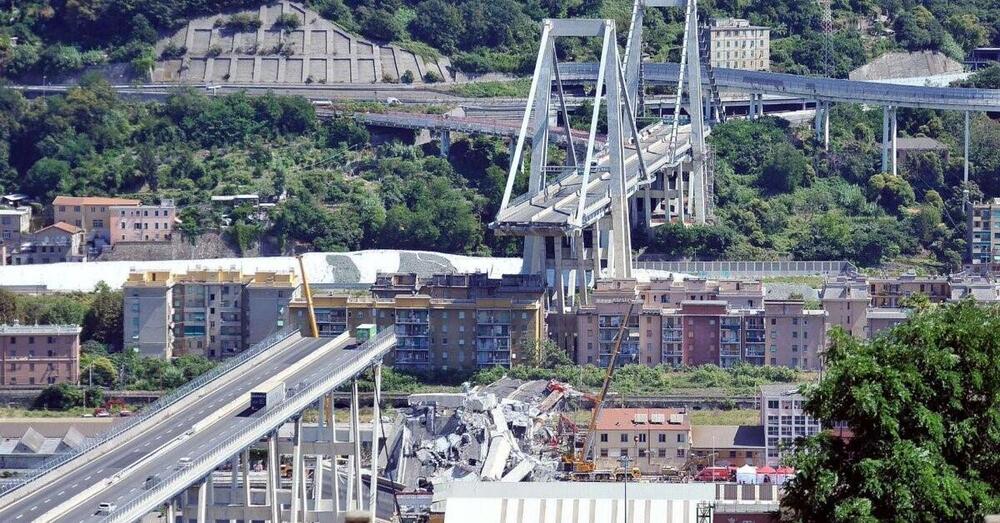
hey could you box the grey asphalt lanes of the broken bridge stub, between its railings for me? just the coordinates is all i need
[0,338,343,523]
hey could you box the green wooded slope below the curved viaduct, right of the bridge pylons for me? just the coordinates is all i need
[648,103,1000,270]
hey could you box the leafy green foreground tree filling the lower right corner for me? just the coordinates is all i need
[782,301,1000,522]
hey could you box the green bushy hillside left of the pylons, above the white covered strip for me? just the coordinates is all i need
[0,78,528,254]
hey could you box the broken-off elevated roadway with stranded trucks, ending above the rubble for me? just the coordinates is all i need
[0,334,390,522]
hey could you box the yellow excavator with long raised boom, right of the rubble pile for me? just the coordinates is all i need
[562,301,642,481]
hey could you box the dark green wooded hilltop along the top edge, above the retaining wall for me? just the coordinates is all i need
[0,0,1000,77]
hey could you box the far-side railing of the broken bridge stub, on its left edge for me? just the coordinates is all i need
[0,328,298,495]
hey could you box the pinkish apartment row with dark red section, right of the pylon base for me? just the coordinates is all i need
[575,280,825,369]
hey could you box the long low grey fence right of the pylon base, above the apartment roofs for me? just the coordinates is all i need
[635,260,858,278]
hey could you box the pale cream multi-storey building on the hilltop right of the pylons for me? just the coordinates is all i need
[708,18,771,71]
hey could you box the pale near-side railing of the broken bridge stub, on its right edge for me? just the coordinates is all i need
[103,328,396,523]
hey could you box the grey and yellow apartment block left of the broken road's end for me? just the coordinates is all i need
[123,269,299,358]
